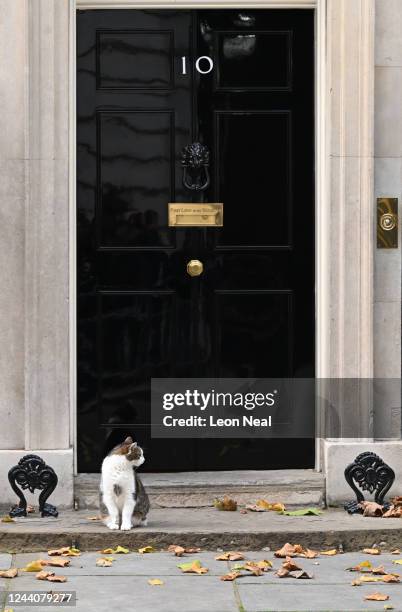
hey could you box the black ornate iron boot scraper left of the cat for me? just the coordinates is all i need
[8,455,59,517]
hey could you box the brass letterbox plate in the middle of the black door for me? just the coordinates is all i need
[169,202,223,227]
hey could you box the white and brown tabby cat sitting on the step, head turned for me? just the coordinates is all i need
[100,437,150,531]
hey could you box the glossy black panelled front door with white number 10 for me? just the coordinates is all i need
[77,9,315,472]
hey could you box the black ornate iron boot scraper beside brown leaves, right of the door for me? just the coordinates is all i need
[344,452,395,514]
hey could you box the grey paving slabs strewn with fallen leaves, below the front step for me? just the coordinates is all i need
[0,551,402,612]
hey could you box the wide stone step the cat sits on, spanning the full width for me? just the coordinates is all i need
[0,508,402,552]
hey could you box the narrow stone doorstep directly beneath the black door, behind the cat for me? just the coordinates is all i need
[74,470,325,509]
